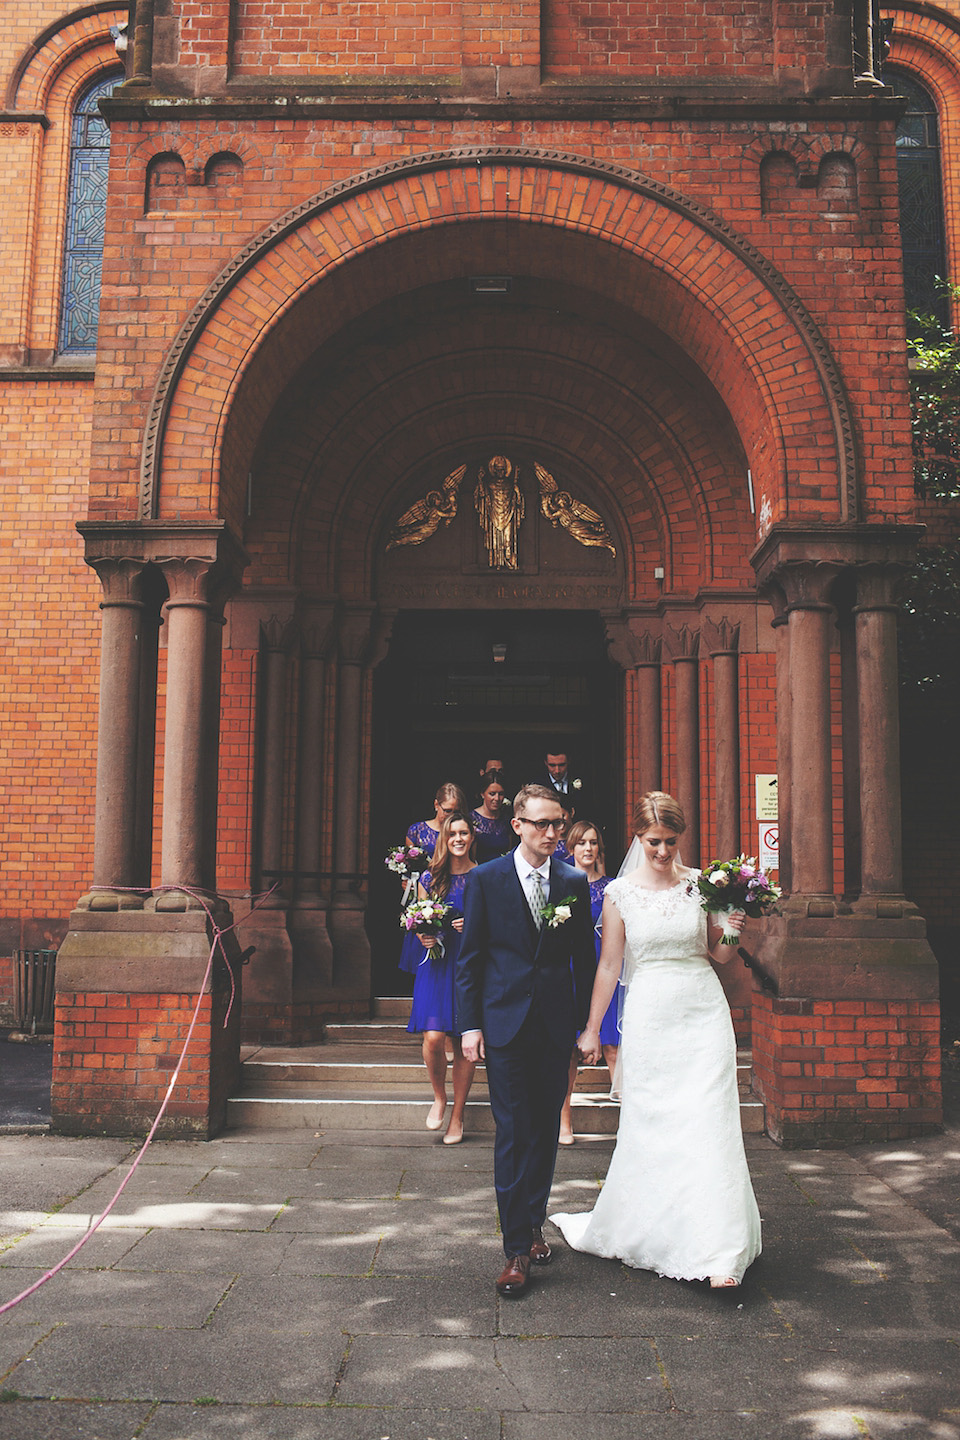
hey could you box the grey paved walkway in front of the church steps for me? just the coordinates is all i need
[0,1086,960,1440]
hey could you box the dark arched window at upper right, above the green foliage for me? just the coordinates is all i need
[884,68,948,324]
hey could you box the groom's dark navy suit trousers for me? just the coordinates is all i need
[486,1012,573,1256]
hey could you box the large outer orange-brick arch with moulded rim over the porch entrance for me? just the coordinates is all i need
[140,148,858,530]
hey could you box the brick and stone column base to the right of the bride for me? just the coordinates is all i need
[753,897,943,1148]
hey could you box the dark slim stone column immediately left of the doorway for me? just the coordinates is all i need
[330,603,374,995]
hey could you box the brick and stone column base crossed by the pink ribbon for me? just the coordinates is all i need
[50,903,242,1139]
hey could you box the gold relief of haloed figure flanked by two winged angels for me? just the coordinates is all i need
[387,455,616,570]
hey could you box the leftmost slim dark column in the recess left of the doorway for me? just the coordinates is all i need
[259,616,294,910]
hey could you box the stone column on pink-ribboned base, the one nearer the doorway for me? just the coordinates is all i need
[157,557,212,910]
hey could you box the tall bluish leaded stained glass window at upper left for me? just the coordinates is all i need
[59,75,122,354]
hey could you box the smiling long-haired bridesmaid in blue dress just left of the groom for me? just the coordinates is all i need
[407,811,476,1145]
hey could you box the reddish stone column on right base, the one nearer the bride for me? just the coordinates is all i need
[780,560,841,914]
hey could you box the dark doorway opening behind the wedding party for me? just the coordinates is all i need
[367,611,623,995]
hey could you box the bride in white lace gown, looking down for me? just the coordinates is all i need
[551,791,760,1287]
